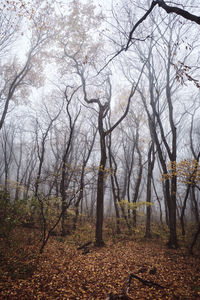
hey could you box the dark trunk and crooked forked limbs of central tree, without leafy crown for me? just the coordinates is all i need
[65,52,146,246]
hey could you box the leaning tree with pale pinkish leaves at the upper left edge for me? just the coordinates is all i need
[0,1,52,130]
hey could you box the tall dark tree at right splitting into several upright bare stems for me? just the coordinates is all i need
[125,14,195,248]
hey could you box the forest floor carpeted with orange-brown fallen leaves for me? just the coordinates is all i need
[0,224,200,300]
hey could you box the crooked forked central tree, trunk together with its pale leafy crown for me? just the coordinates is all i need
[51,1,145,246]
